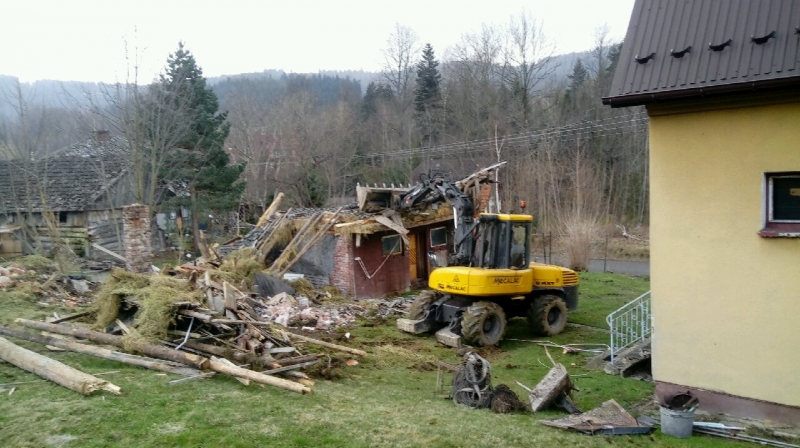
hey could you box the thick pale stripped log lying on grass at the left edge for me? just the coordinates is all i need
[0,337,120,395]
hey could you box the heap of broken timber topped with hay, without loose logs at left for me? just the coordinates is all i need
[85,268,366,390]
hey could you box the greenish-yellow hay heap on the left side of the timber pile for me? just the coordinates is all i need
[93,269,202,342]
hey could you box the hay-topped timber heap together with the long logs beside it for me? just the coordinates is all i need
[0,266,368,394]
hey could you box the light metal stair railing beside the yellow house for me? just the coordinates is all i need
[606,291,652,362]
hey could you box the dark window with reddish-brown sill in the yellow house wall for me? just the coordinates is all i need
[760,172,800,237]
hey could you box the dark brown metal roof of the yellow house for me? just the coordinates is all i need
[603,0,800,107]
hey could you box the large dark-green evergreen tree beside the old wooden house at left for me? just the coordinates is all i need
[159,42,244,249]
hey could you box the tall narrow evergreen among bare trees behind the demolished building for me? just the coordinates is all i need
[414,44,442,144]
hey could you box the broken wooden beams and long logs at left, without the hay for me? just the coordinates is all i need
[0,271,366,394]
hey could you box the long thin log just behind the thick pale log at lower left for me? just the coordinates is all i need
[0,326,202,376]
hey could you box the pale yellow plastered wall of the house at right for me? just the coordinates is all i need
[650,103,800,406]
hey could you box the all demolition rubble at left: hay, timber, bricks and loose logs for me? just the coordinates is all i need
[0,247,384,394]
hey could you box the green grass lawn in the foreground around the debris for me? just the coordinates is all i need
[0,274,744,447]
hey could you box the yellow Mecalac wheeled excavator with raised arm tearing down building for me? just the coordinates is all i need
[397,173,578,347]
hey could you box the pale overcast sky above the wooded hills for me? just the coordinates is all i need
[0,0,633,82]
